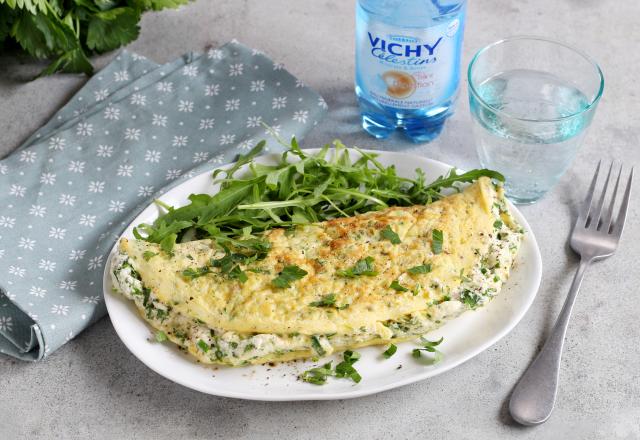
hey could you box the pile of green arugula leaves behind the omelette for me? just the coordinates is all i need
[135,138,503,258]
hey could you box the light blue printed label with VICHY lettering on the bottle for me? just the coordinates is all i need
[356,18,462,109]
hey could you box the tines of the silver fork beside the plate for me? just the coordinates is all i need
[576,161,633,238]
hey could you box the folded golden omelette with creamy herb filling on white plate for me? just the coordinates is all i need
[111,177,523,366]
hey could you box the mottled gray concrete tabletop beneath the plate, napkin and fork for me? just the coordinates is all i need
[0,0,640,440]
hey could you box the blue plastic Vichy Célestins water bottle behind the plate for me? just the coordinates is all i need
[356,0,466,142]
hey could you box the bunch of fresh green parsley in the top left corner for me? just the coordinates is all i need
[0,0,189,75]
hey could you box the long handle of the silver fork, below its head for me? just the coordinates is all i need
[509,258,592,426]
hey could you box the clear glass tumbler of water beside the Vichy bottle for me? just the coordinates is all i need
[468,37,604,204]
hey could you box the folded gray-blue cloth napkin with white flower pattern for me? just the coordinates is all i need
[0,41,326,361]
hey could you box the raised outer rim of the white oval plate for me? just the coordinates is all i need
[102,148,542,402]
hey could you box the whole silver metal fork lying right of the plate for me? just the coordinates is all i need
[509,162,633,425]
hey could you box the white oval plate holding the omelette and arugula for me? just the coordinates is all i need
[104,150,542,401]
